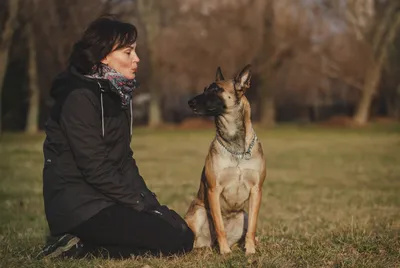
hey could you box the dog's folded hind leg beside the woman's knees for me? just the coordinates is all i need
[185,205,216,248]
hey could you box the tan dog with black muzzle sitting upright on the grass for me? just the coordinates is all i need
[184,65,266,255]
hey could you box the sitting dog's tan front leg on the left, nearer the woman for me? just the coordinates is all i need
[208,185,231,254]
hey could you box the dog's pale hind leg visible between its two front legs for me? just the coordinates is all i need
[224,210,248,247]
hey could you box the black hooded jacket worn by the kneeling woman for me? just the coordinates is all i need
[43,67,160,235]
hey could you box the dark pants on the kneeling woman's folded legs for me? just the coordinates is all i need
[70,205,194,258]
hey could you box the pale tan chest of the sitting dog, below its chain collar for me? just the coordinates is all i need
[218,160,259,212]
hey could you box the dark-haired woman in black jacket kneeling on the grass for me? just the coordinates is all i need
[41,17,193,257]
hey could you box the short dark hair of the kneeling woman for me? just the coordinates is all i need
[69,15,137,74]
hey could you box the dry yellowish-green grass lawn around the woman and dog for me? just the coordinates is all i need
[0,126,400,267]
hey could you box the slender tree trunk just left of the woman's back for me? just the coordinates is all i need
[25,23,40,134]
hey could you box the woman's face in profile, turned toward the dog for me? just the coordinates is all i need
[101,42,140,79]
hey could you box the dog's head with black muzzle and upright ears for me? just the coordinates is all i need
[188,65,251,116]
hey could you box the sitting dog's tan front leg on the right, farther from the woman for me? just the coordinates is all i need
[245,184,262,255]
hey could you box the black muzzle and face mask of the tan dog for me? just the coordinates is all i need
[188,83,226,116]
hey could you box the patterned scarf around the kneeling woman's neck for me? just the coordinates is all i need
[85,64,136,109]
